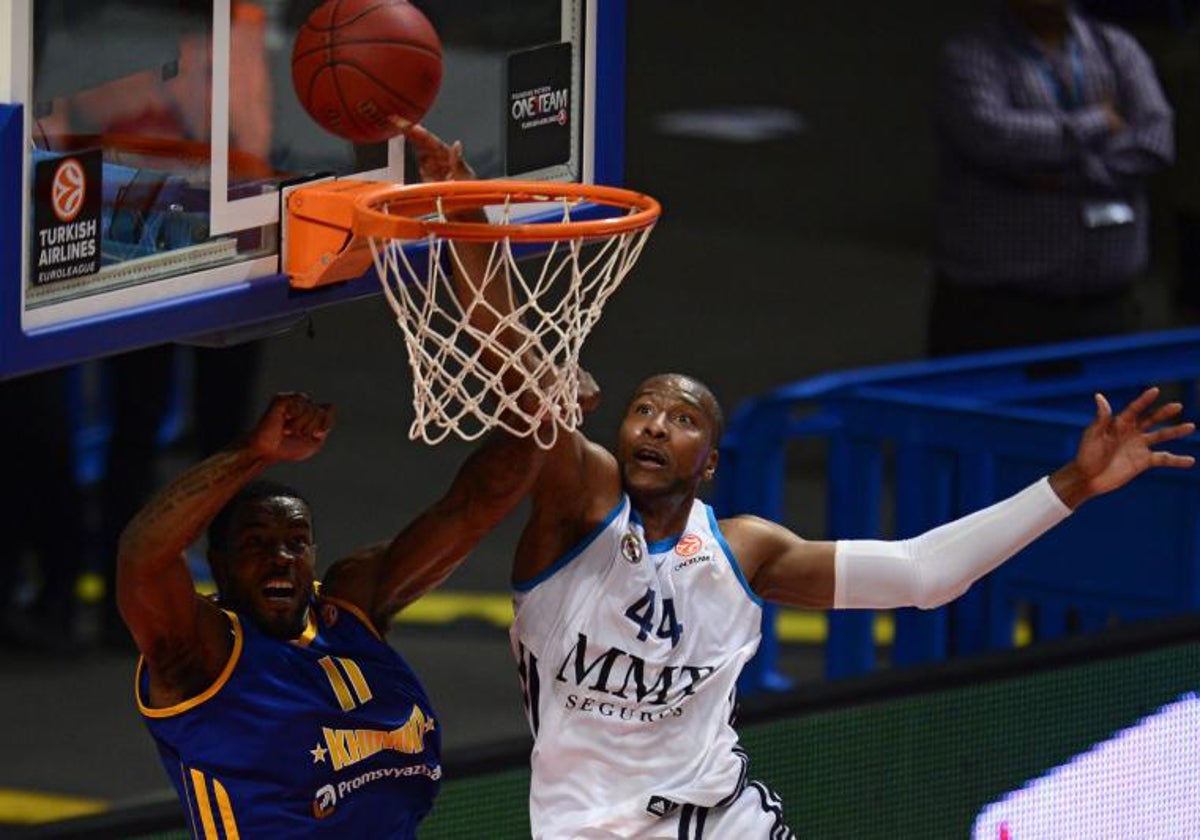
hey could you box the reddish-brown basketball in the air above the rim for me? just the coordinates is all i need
[292,0,442,143]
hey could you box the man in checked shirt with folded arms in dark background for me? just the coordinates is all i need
[928,0,1175,356]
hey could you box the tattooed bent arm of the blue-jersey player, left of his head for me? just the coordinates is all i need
[116,394,334,688]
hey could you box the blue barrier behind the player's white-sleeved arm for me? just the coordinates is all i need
[714,329,1200,690]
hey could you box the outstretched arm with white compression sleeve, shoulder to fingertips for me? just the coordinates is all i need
[727,388,1195,610]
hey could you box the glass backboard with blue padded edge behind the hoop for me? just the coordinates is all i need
[0,0,624,377]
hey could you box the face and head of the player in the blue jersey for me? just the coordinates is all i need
[210,496,316,638]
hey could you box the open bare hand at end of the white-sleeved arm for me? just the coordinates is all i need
[1051,388,1195,508]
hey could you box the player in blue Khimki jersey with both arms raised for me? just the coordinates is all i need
[116,132,542,840]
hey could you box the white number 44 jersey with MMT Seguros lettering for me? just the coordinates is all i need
[511,497,762,839]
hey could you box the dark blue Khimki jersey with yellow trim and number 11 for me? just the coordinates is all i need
[137,598,442,840]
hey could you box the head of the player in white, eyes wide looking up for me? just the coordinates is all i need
[617,374,716,496]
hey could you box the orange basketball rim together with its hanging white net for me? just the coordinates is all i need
[354,181,661,449]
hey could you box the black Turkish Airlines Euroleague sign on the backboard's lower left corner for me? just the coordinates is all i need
[29,149,103,286]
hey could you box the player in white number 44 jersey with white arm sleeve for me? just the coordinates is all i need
[511,374,1195,840]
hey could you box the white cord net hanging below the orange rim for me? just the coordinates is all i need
[370,198,653,449]
